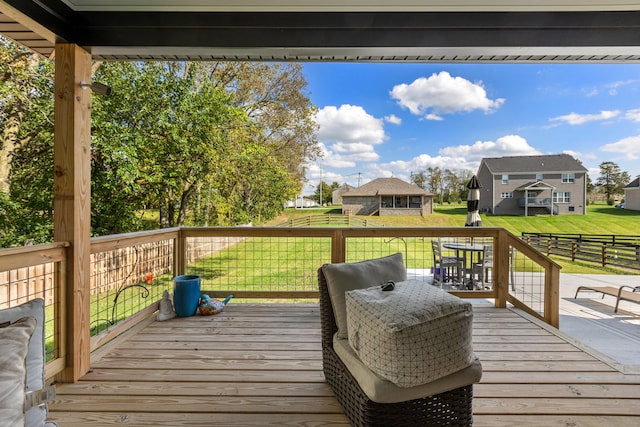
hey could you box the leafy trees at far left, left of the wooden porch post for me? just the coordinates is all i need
[0,37,53,246]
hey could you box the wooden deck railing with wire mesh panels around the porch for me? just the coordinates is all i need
[0,227,559,377]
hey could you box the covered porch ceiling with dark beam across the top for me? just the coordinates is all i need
[0,0,640,63]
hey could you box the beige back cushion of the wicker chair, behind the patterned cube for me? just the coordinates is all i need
[322,253,407,338]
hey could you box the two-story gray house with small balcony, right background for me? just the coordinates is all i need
[477,154,587,216]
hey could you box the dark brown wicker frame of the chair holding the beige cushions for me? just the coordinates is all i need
[318,256,481,427]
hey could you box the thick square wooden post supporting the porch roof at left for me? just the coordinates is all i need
[53,43,91,382]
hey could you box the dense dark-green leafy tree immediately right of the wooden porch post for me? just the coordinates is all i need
[92,62,245,233]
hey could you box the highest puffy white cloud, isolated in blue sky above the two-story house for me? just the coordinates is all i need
[390,71,505,120]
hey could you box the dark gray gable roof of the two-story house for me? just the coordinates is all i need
[482,154,587,174]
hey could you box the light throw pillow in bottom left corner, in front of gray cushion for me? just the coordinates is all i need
[0,317,36,426]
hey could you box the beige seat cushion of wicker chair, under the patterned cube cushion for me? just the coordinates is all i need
[333,334,482,403]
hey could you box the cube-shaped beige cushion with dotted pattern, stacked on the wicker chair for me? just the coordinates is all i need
[346,280,475,387]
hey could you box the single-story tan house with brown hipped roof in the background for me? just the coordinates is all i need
[342,178,433,216]
